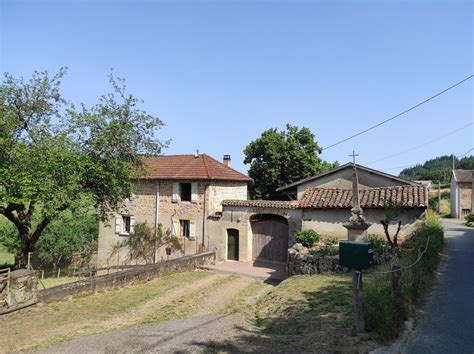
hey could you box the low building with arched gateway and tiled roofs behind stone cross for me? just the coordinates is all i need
[216,163,428,262]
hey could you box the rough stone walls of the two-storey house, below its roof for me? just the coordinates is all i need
[97,180,247,268]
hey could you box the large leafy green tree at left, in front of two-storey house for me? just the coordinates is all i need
[0,69,163,267]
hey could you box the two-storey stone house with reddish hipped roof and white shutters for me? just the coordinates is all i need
[98,154,250,268]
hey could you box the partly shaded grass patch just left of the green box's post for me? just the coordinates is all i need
[255,274,353,351]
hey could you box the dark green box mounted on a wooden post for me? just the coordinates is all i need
[339,241,374,269]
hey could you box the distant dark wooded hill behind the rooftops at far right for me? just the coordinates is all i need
[399,155,474,183]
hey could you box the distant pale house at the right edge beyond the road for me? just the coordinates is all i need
[451,170,474,218]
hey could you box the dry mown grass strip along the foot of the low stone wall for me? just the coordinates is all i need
[0,271,213,352]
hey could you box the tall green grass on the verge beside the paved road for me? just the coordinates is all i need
[364,211,444,340]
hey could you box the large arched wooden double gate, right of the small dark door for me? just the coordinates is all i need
[252,214,288,262]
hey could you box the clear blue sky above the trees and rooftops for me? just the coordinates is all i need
[0,0,474,174]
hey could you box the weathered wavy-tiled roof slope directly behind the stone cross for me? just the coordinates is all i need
[299,185,428,209]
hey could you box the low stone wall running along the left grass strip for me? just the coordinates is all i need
[40,252,216,303]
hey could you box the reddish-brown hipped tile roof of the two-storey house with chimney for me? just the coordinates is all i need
[143,154,251,182]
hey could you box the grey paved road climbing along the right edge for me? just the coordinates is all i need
[402,219,474,354]
